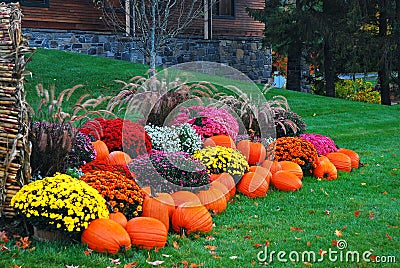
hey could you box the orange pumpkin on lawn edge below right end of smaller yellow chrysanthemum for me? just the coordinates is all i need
[237,172,269,198]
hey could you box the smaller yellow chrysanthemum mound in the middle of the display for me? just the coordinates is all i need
[193,146,249,180]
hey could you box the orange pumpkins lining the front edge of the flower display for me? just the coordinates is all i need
[82,135,360,254]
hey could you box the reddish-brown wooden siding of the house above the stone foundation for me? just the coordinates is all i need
[21,0,265,37]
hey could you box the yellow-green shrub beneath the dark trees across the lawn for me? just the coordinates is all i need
[335,79,381,103]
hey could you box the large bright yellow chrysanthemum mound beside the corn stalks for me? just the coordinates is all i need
[11,173,108,233]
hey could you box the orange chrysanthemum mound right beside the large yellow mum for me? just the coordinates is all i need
[80,170,146,219]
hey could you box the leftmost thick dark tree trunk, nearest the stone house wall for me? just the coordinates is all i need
[286,42,301,91]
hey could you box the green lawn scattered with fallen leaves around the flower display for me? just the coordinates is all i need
[0,51,400,267]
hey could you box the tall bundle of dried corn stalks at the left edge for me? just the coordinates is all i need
[0,3,33,218]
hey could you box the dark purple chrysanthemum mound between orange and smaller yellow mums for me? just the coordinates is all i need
[128,150,210,193]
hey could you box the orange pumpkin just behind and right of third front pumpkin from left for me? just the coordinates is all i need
[197,187,226,215]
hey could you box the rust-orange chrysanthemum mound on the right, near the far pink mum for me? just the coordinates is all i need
[267,137,318,175]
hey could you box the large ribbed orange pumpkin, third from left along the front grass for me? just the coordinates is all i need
[172,202,212,235]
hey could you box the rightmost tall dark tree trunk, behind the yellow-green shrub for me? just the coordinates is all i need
[378,0,391,105]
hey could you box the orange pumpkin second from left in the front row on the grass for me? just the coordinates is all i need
[126,217,168,249]
